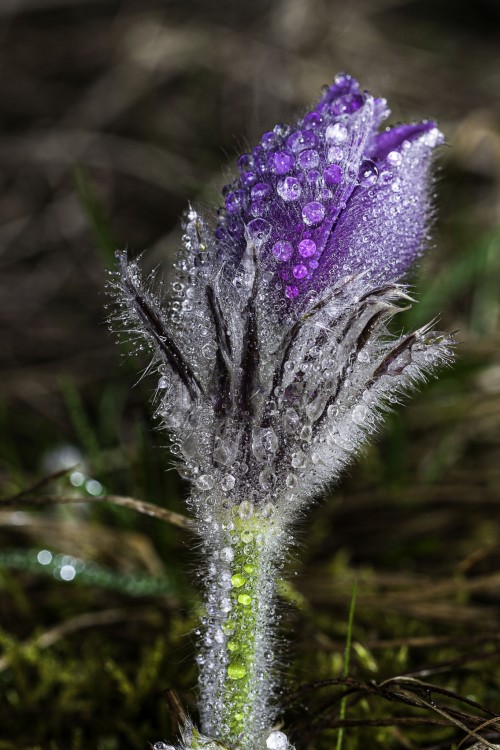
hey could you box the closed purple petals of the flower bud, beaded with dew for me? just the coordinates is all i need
[216,75,442,308]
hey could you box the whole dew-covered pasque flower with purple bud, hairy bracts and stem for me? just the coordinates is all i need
[115,75,450,750]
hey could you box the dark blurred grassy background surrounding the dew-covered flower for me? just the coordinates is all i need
[0,0,500,750]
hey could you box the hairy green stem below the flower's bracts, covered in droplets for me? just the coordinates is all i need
[199,501,282,750]
